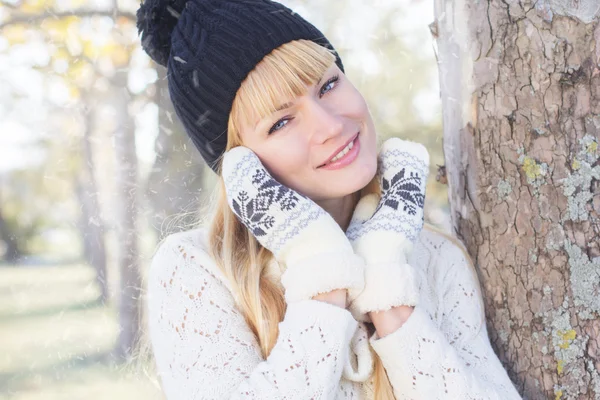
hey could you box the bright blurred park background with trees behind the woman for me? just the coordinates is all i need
[0,0,449,400]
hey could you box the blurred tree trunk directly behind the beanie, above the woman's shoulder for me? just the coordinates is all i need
[146,67,205,237]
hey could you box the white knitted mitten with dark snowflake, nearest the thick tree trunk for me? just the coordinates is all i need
[346,138,429,321]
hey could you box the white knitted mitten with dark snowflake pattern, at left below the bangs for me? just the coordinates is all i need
[222,146,364,302]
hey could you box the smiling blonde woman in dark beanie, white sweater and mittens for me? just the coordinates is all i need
[138,0,520,400]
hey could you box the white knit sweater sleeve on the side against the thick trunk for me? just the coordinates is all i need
[370,236,521,400]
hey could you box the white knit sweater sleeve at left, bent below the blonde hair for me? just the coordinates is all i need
[147,234,357,400]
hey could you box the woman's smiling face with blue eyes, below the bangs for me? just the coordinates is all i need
[240,64,377,201]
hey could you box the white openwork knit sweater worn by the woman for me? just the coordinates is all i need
[147,229,521,400]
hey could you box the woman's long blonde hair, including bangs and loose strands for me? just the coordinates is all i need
[131,40,482,400]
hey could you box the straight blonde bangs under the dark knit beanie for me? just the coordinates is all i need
[227,40,335,149]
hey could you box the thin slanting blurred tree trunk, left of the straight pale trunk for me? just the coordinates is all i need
[75,98,109,304]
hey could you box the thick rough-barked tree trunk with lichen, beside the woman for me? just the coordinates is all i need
[430,0,600,399]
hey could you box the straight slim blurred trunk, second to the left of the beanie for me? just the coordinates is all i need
[111,71,142,360]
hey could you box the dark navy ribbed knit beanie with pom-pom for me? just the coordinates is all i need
[137,0,344,173]
